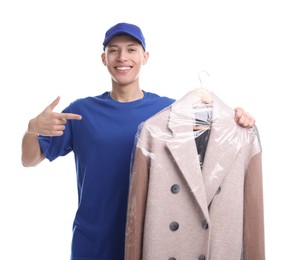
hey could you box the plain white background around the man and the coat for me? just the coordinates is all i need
[0,0,296,260]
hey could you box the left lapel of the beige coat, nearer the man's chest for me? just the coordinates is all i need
[167,91,209,220]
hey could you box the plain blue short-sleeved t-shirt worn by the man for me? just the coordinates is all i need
[39,92,175,260]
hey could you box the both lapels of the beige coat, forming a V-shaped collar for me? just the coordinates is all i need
[167,90,239,213]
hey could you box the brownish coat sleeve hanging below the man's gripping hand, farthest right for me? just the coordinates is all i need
[243,152,265,260]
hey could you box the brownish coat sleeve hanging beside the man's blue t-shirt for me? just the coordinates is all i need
[125,142,149,260]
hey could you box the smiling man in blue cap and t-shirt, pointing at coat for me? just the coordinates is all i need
[22,23,255,260]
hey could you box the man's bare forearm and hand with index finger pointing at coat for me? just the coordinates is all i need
[21,97,82,167]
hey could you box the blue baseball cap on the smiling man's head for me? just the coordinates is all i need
[103,23,146,50]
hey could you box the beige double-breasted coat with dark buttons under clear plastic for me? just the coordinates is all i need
[125,89,265,260]
